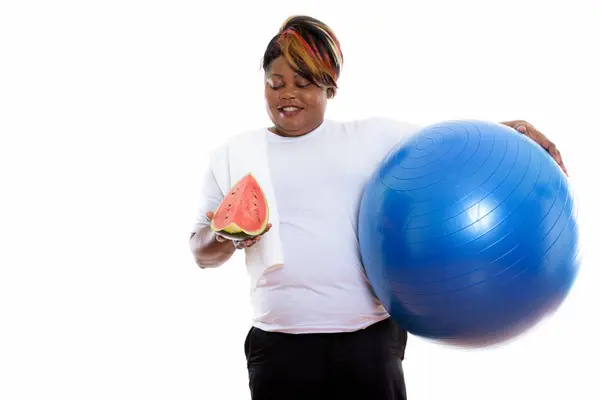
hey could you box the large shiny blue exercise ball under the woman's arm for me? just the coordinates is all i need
[358,120,579,347]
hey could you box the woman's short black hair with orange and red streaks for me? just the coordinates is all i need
[262,15,344,97]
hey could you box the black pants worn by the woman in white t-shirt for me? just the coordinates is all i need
[245,318,407,400]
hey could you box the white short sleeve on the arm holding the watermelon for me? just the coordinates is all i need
[191,147,229,233]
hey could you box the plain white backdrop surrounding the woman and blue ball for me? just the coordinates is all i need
[0,0,600,400]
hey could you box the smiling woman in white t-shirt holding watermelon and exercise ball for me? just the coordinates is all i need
[190,16,564,400]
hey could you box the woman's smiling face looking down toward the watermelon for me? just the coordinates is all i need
[265,57,327,136]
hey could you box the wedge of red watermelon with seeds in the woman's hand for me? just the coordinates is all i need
[210,174,269,240]
